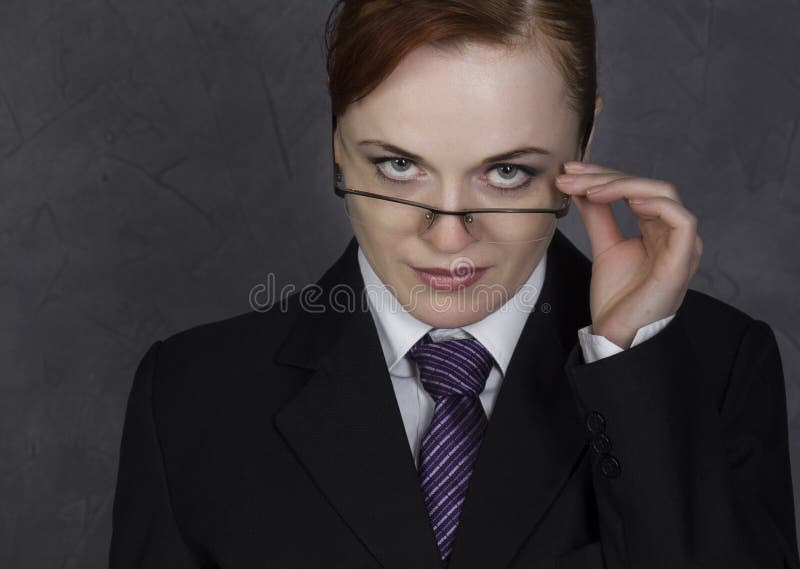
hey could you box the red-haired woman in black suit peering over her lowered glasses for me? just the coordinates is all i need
[111,0,800,569]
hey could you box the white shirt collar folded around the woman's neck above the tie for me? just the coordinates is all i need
[358,247,547,376]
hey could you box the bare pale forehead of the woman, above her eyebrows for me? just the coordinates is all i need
[341,43,578,156]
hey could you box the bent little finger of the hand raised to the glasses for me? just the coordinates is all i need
[629,197,697,281]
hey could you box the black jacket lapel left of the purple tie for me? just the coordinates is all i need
[275,240,441,569]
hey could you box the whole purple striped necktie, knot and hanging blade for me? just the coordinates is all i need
[408,334,493,566]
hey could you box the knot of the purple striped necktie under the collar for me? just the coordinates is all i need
[408,334,493,401]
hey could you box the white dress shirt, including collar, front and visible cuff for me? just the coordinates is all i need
[358,247,675,465]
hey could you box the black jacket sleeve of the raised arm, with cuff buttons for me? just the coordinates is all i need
[565,313,800,569]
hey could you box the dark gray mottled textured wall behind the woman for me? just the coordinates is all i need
[0,0,800,569]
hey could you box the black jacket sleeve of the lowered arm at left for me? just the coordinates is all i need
[109,341,202,569]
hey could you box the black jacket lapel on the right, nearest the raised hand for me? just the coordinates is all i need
[450,230,590,569]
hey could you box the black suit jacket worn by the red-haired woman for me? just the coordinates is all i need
[110,231,800,569]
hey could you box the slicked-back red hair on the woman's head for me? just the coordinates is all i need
[325,0,597,150]
